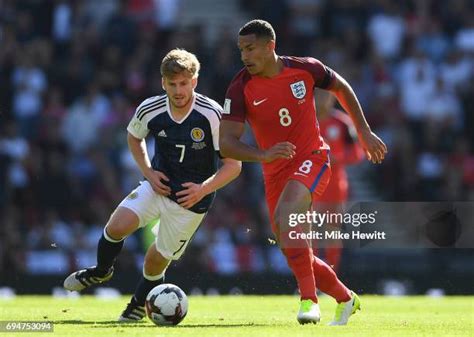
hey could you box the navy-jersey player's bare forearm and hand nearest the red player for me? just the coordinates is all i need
[176,158,242,208]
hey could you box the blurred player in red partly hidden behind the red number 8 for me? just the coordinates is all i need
[313,90,364,272]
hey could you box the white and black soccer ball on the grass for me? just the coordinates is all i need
[145,283,188,325]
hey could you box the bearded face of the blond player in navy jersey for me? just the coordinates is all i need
[162,72,197,109]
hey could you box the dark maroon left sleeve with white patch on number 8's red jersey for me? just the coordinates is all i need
[222,71,247,123]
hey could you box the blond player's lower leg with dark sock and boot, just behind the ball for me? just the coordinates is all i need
[118,243,170,322]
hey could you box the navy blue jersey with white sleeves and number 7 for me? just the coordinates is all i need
[127,93,222,213]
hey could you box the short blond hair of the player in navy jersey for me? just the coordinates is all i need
[160,48,201,78]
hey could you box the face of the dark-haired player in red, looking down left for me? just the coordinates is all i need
[238,34,275,75]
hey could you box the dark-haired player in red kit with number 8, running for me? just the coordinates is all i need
[219,20,387,325]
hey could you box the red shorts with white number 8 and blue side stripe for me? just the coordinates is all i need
[265,150,331,232]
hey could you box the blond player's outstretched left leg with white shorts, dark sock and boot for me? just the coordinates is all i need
[64,182,158,291]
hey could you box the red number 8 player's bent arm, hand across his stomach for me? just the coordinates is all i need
[219,120,296,163]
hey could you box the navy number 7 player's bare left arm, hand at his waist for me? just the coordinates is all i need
[127,132,171,196]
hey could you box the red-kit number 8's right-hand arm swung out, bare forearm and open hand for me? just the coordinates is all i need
[328,73,387,163]
